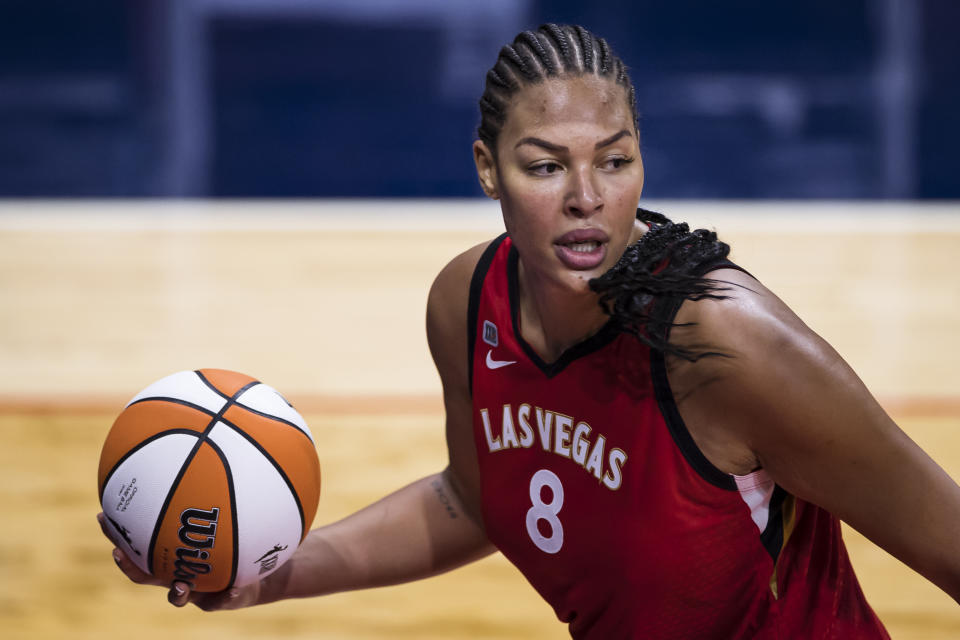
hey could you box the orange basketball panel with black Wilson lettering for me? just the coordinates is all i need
[153,443,236,591]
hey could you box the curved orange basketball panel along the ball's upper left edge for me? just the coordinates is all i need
[97,400,210,493]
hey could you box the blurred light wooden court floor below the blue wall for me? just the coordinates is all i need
[0,202,960,640]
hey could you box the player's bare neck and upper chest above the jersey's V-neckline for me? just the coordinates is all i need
[517,263,609,362]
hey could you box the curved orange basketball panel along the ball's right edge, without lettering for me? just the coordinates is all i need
[223,405,320,536]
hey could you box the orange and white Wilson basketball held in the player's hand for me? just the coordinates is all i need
[98,369,320,591]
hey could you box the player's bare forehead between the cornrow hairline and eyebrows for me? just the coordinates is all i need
[500,74,634,138]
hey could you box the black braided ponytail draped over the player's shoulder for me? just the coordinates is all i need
[589,209,730,362]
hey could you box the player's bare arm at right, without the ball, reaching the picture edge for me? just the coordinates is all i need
[677,270,960,601]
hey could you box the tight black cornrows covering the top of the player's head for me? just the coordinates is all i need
[477,23,639,155]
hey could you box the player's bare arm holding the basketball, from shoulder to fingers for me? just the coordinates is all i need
[101,241,493,610]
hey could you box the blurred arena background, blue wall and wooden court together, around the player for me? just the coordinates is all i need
[0,0,960,640]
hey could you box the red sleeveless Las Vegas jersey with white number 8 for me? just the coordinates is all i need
[468,235,888,640]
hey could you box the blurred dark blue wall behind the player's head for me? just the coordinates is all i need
[0,0,960,198]
